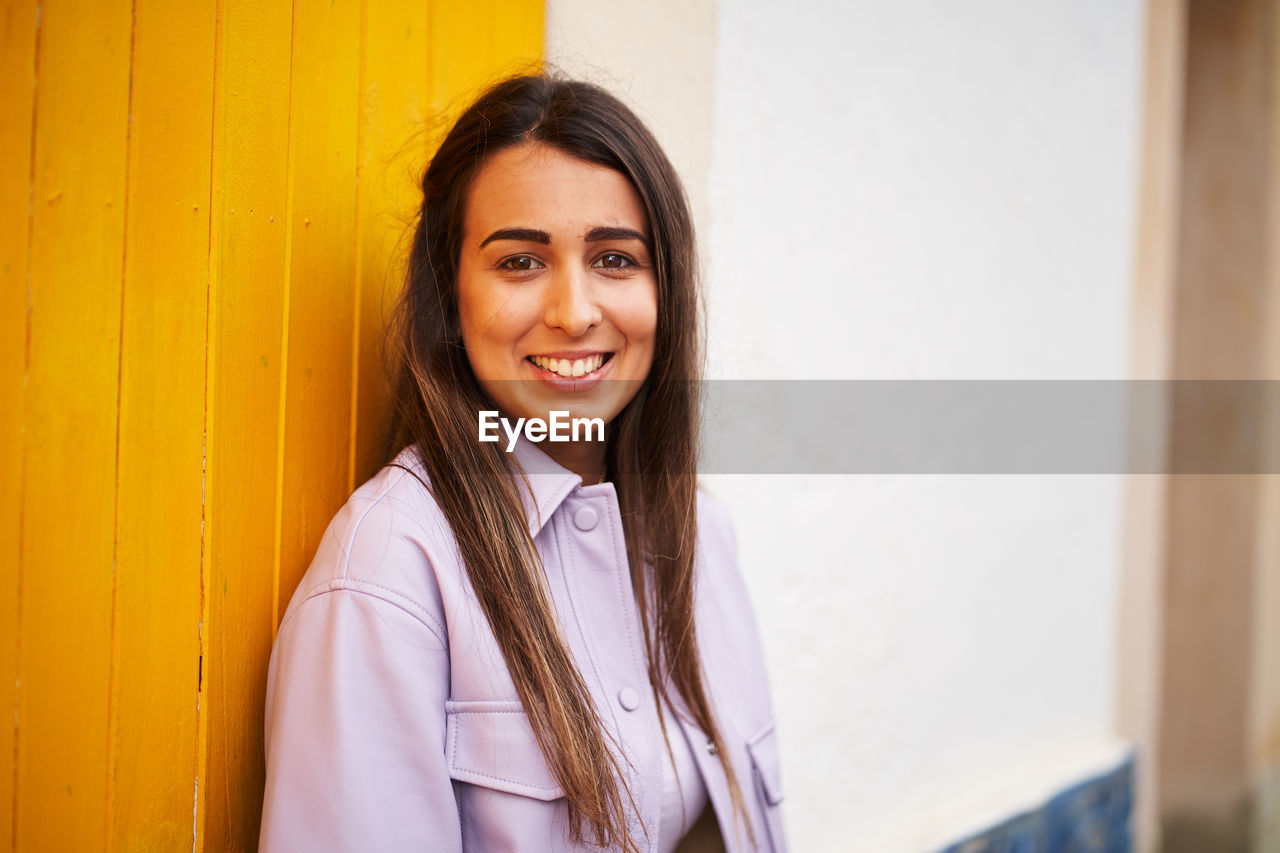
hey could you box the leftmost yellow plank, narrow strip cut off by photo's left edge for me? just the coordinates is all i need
[0,0,36,847]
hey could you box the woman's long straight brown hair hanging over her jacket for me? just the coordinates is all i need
[392,76,754,850]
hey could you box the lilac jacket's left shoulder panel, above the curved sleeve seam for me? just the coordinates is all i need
[282,448,461,637]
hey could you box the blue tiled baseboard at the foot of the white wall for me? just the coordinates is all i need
[938,754,1134,853]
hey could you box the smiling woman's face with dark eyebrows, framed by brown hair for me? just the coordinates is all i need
[458,143,658,432]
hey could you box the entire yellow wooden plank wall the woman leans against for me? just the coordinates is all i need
[0,0,543,852]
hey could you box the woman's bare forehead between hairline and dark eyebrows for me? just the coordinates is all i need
[463,143,649,243]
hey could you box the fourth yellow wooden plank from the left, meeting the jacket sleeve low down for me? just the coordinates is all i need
[196,0,292,853]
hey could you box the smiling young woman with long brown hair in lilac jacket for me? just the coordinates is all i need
[262,76,785,853]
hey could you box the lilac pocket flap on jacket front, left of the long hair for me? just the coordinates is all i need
[444,701,564,800]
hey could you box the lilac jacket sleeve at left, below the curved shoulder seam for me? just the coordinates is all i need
[261,580,462,853]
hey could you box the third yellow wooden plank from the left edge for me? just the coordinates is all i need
[108,0,215,850]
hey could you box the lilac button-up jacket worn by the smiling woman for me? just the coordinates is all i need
[261,439,786,853]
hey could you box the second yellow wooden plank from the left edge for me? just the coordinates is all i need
[15,0,132,850]
